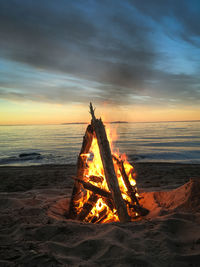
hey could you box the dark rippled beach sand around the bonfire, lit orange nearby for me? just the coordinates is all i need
[0,163,200,267]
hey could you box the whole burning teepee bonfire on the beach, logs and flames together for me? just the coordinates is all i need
[69,103,148,223]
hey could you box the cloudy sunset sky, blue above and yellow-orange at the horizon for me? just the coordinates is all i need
[0,0,200,124]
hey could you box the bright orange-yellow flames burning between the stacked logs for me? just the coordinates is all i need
[76,125,138,223]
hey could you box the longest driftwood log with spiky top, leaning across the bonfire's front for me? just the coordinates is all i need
[90,103,130,222]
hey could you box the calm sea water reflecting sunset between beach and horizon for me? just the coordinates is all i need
[0,122,200,165]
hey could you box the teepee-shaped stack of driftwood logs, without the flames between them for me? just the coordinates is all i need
[68,103,148,222]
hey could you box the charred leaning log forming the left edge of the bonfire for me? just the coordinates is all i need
[68,125,93,219]
